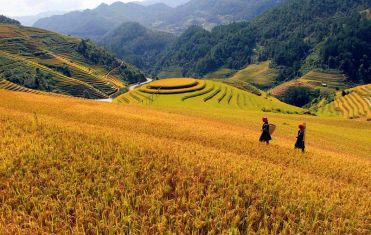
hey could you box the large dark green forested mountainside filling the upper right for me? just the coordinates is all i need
[157,0,371,83]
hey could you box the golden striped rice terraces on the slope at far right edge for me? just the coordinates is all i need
[318,84,371,120]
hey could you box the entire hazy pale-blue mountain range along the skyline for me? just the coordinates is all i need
[34,0,281,38]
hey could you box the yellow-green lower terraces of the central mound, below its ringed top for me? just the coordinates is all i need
[114,79,303,113]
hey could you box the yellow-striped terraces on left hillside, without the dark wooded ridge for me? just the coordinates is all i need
[0,24,132,99]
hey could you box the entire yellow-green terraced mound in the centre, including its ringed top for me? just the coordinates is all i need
[115,78,303,113]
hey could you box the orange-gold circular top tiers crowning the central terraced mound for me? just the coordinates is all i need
[139,78,206,94]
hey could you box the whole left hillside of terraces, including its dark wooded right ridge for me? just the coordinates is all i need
[0,24,145,99]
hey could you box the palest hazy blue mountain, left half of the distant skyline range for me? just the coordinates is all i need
[34,2,172,41]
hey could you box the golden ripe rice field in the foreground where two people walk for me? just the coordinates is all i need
[0,89,371,234]
